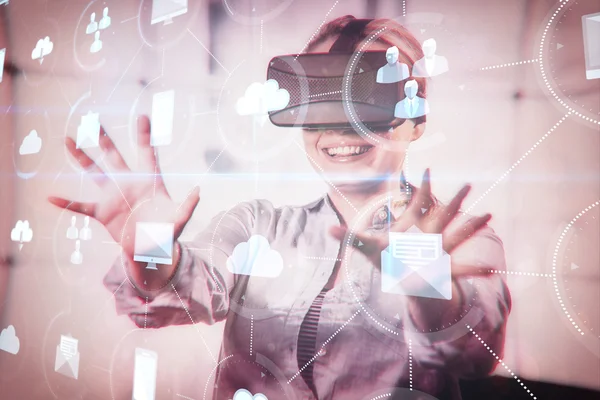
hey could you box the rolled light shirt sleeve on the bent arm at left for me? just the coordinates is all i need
[104,203,258,328]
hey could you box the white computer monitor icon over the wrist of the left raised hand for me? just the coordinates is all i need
[133,222,175,269]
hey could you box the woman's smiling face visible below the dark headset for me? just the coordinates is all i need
[303,39,424,190]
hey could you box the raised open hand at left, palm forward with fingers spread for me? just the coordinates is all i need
[48,116,200,287]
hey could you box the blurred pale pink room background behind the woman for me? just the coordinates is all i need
[0,0,600,400]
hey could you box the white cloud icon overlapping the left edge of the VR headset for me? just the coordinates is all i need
[235,79,290,121]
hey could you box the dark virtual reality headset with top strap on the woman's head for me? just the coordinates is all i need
[267,19,403,129]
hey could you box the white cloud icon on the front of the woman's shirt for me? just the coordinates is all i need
[227,235,283,278]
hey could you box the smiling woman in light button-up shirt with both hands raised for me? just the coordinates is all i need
[50,16,510,399]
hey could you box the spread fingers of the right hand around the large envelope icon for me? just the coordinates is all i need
[331,169,492,278]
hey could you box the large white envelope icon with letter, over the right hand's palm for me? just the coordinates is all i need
[381,226,452,300]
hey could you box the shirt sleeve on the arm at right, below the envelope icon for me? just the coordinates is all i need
[404,220,511,378]
